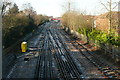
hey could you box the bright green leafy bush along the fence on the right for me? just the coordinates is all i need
[78,28,120,46]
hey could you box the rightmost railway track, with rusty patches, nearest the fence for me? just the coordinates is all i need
[59,27,120,79]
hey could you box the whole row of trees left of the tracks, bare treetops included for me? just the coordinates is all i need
[2,2,48,48]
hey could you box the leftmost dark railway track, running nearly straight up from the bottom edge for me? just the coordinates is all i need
[35,26,58,80]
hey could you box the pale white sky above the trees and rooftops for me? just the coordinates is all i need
[4,0,120,17]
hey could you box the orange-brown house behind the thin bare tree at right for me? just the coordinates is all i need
[93,11,120,32]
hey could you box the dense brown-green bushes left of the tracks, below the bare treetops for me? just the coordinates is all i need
[2,4,48,48]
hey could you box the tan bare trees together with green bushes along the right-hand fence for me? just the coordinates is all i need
[62,11,120,46]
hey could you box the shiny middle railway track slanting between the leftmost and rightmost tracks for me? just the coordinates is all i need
[50,29,81,80]
